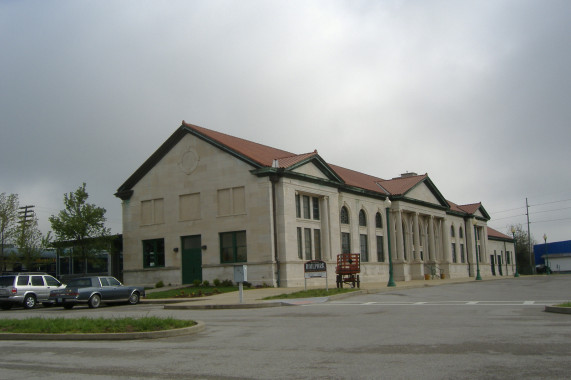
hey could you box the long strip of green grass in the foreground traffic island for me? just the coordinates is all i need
[0,317,196,334]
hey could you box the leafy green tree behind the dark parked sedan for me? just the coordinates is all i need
[49,182,111,273]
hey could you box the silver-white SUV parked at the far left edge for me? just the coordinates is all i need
[0,272,65,310]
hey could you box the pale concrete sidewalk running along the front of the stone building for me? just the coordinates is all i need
[141,276,513,310]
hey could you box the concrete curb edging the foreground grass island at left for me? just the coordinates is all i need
[0,321,206,340]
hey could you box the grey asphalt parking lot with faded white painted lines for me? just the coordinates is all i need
[0,275,571,379]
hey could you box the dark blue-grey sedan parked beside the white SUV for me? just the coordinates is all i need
[49,276,145,309]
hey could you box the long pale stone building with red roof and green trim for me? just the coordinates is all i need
[115,121,515,287]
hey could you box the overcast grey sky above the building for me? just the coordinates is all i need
[0,0,571,242]
